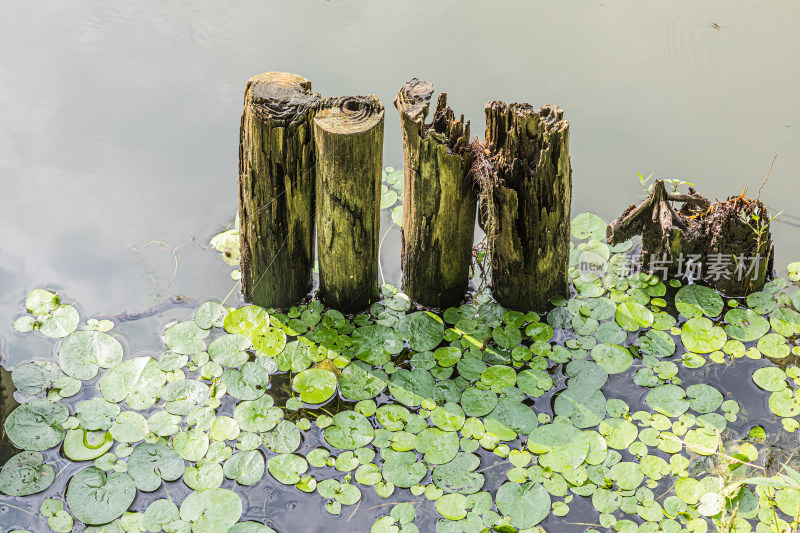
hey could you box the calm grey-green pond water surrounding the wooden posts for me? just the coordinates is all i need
[0,0,800,532]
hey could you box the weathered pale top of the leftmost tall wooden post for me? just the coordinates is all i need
[245,72,320,120]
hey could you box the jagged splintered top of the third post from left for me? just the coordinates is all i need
[394,78,469,154]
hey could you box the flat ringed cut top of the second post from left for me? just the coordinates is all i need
[314,94,383,135]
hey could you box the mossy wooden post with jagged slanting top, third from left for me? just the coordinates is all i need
[394,78,477,308]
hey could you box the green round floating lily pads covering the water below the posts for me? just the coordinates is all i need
[0,169,800,533]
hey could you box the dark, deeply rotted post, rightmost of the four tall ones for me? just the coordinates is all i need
[482,102,572,312]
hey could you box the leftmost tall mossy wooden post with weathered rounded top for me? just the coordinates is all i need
[239,72,319,308]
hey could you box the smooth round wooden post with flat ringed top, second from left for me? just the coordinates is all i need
[314,95,384,312]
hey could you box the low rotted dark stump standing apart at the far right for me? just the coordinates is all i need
[606,180,774,296]
